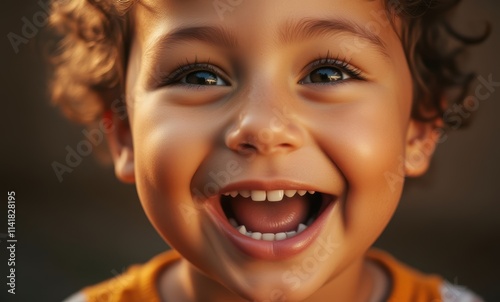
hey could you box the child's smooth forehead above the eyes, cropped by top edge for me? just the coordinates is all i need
[133,0,395,52]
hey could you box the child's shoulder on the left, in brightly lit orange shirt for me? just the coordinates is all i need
[64,251,180,302]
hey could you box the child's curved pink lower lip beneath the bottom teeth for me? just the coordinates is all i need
[203,198,336,260]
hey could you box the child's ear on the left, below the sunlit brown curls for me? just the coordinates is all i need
[103,110,135,183]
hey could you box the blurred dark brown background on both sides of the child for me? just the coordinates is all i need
[0,0,500,301]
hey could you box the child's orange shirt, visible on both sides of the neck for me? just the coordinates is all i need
[83,250,481,302]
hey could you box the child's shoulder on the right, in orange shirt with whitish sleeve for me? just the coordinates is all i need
[367,250,483,302]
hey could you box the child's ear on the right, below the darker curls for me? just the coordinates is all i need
[405,118,443,177]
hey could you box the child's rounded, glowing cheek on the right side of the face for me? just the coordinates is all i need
[314,91,407,236]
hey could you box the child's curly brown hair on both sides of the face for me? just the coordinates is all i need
[50,0,490,123]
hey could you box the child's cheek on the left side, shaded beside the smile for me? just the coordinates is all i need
[133,102,216,246]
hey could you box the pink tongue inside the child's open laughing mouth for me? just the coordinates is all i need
[231,194,310,233]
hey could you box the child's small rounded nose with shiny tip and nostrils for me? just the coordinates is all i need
[225,99,305,155]
